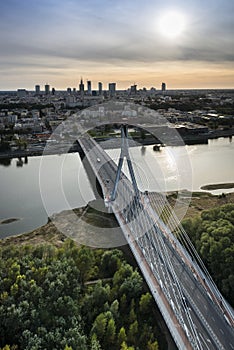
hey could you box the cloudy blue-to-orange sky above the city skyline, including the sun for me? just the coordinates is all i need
[0,0,234,90]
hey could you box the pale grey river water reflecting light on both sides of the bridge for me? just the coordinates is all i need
[0,138,234,238]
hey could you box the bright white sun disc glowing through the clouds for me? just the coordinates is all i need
[158,11,186,39]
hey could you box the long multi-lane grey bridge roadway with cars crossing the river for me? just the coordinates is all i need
[79,136,234,350]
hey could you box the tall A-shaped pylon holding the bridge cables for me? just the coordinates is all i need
[111,124,139,201]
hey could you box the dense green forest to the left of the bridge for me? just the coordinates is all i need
[0,240,166,350]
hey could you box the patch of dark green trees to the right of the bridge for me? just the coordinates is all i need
[183,203,234,306]
